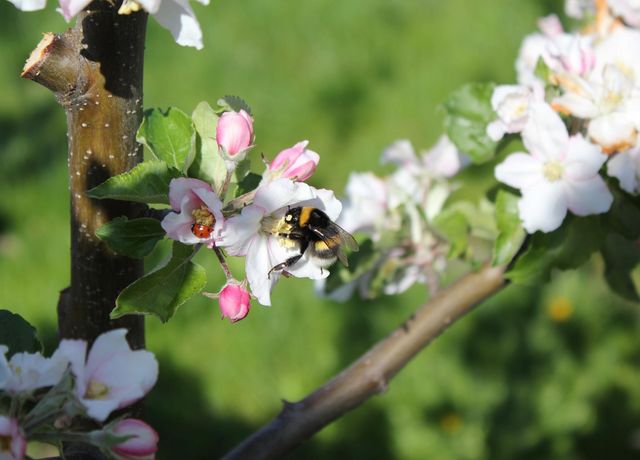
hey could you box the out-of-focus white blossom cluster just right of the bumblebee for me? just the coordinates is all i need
[316,136,469,301]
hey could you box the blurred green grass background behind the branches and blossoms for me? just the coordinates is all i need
[0,0,640,460]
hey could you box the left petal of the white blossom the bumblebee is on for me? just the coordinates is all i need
[217,205,265,256]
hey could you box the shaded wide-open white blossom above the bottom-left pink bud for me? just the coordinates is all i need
[59,329,158,422]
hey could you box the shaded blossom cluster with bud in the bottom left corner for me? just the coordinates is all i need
[0,329,158,460]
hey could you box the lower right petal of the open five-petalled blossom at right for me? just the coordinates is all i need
[564,176,613,216]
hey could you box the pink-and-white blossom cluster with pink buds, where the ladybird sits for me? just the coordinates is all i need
[161,104,342,322]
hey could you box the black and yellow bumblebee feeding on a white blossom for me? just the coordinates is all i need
[269,206,358,275]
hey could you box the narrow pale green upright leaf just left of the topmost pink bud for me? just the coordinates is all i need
[189,102,227,190]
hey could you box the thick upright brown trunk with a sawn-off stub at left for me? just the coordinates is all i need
[22,0,147,348]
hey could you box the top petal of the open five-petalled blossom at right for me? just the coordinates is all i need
[522,102,569,161]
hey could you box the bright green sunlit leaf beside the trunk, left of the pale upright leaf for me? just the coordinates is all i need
[136,107,196,173]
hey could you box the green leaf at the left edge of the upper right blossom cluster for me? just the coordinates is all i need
[444,83,498,163]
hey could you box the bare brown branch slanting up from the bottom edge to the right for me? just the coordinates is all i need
[224,267,506,460]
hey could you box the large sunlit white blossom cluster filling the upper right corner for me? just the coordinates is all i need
[487,0,640,233]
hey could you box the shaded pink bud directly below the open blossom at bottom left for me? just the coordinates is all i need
[111,418,158,460]
